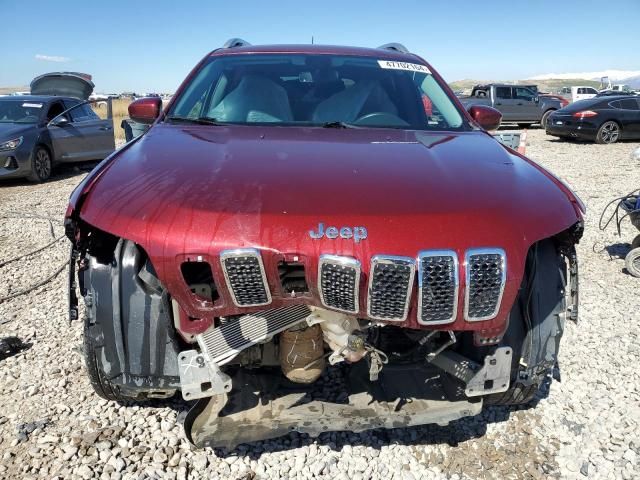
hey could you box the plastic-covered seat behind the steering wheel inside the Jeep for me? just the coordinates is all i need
[312,80,398,123]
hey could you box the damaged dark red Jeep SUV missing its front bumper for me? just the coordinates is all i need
[66,39,584,447]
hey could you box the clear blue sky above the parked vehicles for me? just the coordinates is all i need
[0,0,640,92]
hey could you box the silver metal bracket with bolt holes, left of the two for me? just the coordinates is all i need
[178,350,232,400]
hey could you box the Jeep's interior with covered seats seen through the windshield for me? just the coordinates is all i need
[173,58,461,128]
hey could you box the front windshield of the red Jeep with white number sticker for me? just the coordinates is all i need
[168,54,464,130]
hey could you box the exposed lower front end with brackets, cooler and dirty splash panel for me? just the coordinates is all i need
[179,305,512,448]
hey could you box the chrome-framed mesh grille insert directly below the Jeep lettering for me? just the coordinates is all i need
[318,255,360,313]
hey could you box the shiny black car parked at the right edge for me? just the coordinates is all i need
[546,95,640,143]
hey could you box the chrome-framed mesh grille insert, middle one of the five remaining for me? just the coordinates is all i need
[367,255,415,321]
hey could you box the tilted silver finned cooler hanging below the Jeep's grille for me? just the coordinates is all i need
[198,305,311,362]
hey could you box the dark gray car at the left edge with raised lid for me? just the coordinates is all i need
[0,73,115,182]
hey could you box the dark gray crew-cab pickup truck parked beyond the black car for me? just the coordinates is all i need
[460,83,562,127]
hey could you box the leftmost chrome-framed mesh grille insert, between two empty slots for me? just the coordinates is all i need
[220,248,271,307]
